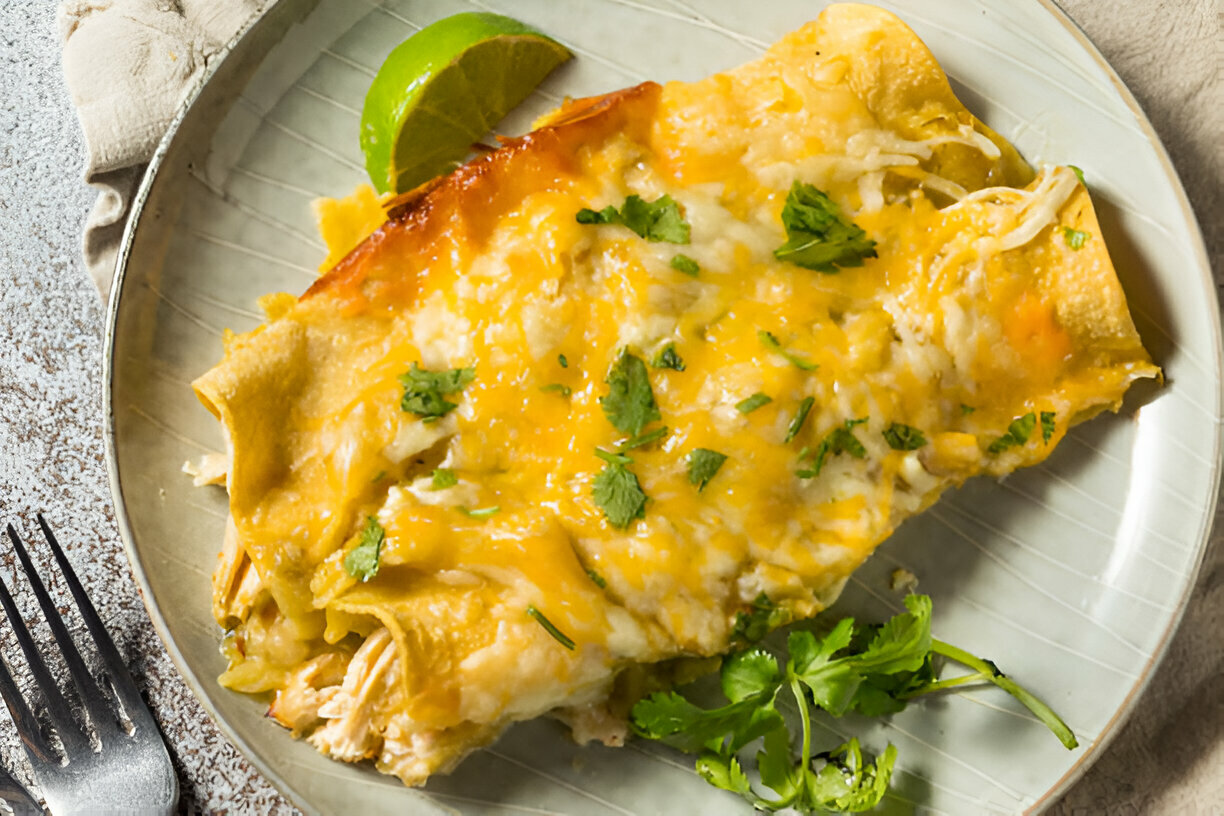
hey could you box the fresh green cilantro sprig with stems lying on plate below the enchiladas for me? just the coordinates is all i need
[630,595,1077,814]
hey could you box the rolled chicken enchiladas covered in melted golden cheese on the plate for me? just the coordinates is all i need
[196,5,1158,784]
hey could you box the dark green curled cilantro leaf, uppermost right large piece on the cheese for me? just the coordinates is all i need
[774,181,875,272]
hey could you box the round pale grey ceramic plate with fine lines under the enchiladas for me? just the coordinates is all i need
[108,0,1220,815]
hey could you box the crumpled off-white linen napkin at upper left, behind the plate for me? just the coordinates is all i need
[58,0,271,299]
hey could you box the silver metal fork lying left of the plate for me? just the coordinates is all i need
[0,514,179,816]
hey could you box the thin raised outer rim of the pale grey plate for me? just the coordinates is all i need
[102,0,1224,816]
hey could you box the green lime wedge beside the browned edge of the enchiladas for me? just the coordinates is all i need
[361,12,570,193]
